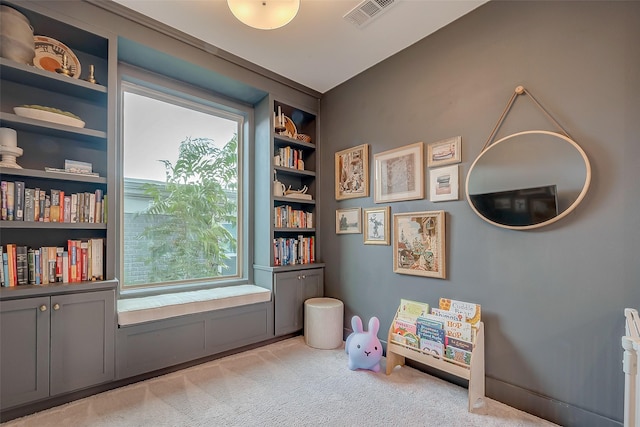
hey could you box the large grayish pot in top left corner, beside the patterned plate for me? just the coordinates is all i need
[0,5,35,64]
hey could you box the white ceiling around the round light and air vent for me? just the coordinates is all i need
[115,0,486,93]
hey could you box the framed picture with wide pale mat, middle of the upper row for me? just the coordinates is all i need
[374,142,424,203]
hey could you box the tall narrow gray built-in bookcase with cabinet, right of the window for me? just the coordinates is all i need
[254,96,324,336]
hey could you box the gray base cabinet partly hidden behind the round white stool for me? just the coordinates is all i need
[274,268,324,335]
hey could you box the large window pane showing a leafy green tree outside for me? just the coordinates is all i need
[120,82,244,289]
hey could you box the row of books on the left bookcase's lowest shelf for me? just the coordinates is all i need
[0,238,104,287]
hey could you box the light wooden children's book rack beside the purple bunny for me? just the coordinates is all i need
[387,306,487,414]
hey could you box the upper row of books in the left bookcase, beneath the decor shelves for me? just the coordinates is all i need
[0,181,107,224]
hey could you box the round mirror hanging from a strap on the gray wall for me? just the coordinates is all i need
[466,130,591,230]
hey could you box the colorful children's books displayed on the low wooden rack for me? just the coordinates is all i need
[391,298,481,365]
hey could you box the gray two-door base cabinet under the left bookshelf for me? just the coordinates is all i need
[0,282,116,409]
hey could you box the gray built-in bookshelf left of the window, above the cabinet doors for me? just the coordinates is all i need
[0,2,114,295]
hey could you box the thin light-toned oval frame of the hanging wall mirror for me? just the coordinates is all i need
[465,130,591,230]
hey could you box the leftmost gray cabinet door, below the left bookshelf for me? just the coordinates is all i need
[0,297,50,408]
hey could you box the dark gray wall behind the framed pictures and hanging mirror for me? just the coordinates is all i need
[320,1,640,426]
